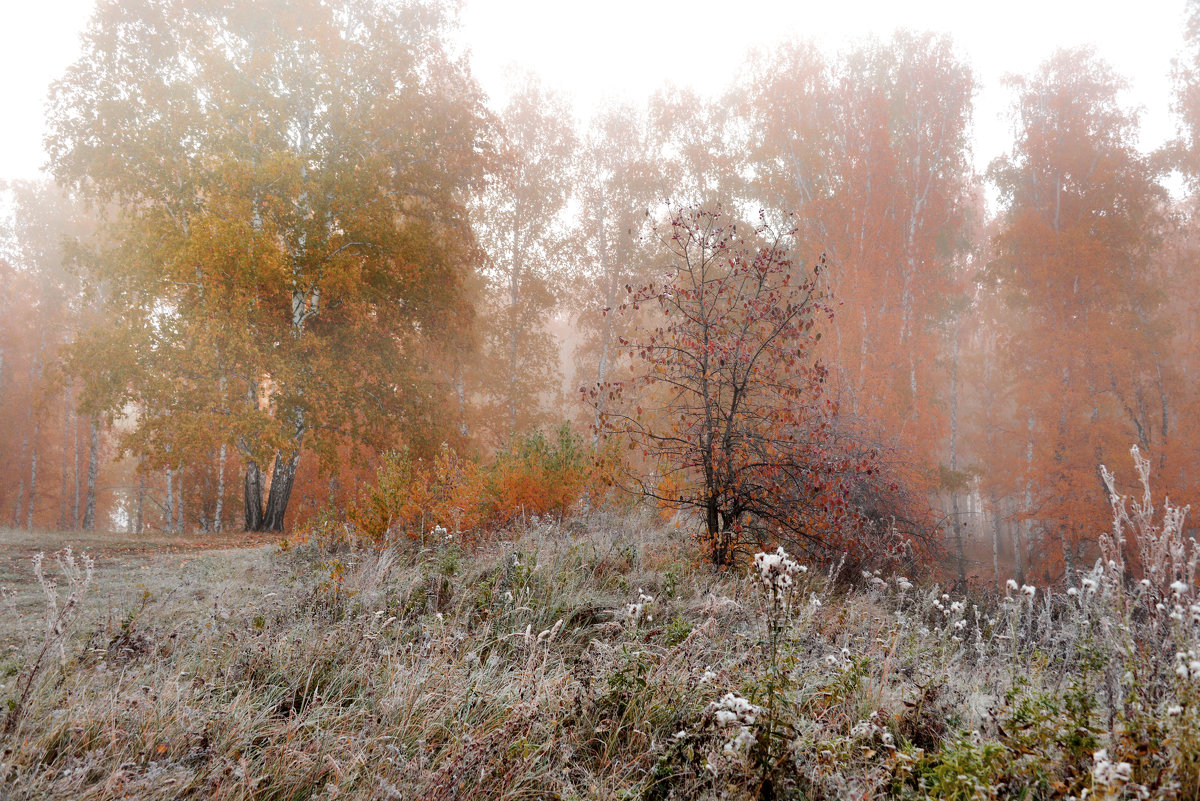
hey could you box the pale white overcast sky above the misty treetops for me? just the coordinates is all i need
[0,0,1183,179]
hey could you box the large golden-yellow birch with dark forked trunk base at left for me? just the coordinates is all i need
[48,0,484,531]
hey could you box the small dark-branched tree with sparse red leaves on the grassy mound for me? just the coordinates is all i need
[593,209,883,564]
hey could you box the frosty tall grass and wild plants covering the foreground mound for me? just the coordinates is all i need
[0,474,1200,799]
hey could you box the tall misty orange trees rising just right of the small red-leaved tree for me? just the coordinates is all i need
[742,32,976,489]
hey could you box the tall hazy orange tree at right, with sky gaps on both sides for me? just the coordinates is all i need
[980,50,1172,578]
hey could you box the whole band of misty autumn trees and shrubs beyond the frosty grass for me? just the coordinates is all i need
[0,0,1200,586]
